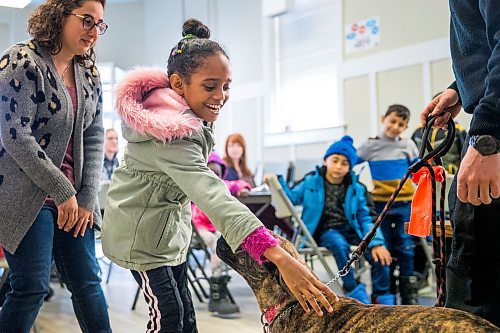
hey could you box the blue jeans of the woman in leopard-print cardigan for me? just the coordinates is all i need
[0,206,111,333]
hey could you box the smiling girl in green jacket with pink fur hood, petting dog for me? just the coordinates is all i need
[102,19,337,332]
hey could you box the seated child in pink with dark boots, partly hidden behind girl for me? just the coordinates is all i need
[191,151,252,314]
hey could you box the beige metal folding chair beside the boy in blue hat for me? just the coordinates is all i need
[268,175,343,294]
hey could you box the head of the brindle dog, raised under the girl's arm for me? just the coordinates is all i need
[217,232,306,311]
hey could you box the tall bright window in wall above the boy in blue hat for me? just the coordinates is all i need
[266,0,342,133]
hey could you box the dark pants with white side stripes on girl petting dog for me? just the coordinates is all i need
[131,263,198,333]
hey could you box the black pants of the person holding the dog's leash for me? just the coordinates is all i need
[445,170,500,326]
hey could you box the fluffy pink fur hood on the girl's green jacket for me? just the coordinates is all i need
[115,68,203,142]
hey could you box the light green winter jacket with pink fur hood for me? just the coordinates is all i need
[102,69,262,271]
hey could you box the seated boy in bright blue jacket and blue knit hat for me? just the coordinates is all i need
[270,136,394,305]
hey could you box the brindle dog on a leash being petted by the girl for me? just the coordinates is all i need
[217,232,500,333]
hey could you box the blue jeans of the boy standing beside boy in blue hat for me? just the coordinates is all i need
[375,201,415,276]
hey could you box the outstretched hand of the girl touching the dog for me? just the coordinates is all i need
[264,246,339,316]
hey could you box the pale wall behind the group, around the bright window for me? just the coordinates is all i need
[0,0,470,182]
